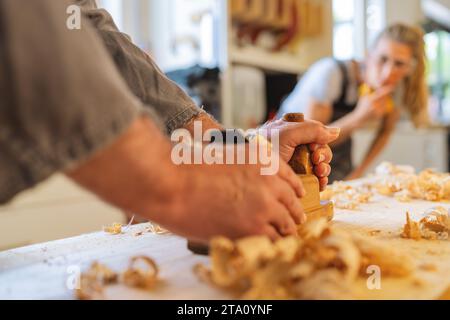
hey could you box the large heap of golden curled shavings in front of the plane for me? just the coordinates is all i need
[194,219,413,300]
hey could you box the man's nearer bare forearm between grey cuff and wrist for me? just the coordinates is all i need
[67,118,183,226]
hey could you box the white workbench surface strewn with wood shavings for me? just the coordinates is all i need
[0,190,450,299]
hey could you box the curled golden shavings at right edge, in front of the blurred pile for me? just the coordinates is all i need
[401,207,450,240]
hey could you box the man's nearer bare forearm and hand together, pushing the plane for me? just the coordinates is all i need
[67,119,306,242]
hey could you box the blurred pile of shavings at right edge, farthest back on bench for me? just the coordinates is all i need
[373,162,450,202]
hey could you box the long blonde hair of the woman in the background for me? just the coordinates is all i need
[375,23,430,127]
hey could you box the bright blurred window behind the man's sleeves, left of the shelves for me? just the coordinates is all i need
[97,0,219,71]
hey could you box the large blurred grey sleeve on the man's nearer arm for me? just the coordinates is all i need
[0,0,159,203]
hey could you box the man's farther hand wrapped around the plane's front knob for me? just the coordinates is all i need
[261,120,340,191]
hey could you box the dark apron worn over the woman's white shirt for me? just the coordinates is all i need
[329,60,356,183]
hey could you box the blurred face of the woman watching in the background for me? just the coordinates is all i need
[366,38,414,89]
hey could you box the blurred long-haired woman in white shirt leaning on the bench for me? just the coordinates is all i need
[280,24,429,182]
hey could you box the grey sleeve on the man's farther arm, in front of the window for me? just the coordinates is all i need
[74,0,204,133]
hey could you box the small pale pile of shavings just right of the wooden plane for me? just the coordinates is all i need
[321,182,373,210]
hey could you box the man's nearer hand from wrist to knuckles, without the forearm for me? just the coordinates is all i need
[175,163,306,241]
